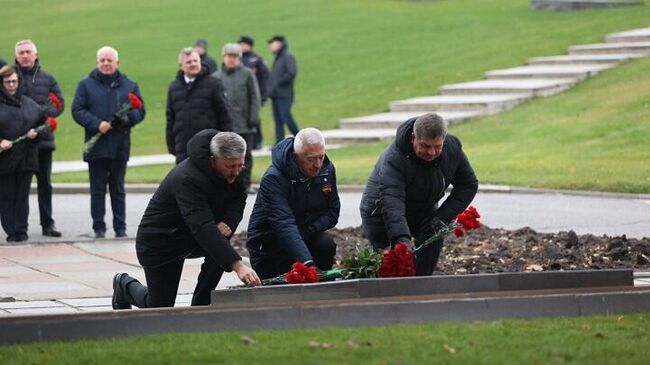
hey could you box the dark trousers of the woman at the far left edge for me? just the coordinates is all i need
[0,172,33,238]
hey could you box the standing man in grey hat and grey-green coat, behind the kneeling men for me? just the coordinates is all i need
[214,43,260,194]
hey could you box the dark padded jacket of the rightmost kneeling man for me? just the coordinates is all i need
[360,118,478,242]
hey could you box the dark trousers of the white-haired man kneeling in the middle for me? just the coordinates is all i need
[251,232,336,279]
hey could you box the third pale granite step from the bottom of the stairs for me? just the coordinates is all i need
[390,94,531,114]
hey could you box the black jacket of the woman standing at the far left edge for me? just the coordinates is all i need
[0,82,45,175]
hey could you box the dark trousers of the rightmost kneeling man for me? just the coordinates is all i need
[361,216,443,276]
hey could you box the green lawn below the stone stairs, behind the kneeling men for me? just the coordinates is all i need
[54,55,650,193]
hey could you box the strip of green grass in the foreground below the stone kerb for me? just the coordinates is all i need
[0,313,650,365]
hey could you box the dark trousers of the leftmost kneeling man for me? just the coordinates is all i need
[120,257,223,308]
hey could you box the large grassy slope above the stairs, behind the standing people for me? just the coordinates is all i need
[0,0,650,160]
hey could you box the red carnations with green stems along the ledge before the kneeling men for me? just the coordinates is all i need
[262,206,481,285]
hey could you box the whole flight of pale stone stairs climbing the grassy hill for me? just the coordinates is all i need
[323,28,650,145]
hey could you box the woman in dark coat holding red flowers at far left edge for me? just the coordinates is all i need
[0,66,45,242]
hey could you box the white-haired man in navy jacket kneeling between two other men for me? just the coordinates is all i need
[246,128,341,278]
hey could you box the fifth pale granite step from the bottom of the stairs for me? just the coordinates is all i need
[485,65,611,81]
